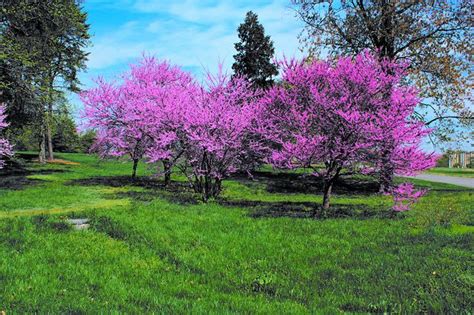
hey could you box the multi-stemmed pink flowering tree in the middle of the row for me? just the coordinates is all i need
[180,70,266,202]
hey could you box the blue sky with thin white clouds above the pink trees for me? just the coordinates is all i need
[73,0,303,92]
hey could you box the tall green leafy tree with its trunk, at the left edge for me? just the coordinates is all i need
[1,0,89,161]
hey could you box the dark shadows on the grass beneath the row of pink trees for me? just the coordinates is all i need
[68,172,392,219]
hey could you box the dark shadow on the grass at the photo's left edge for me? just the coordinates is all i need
[0,154,68,190]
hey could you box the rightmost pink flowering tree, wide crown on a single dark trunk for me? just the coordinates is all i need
[259,53,435,214]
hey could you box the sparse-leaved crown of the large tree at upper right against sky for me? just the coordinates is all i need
[293,0,473,141]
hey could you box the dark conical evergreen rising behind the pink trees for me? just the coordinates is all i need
[232,11,278,88]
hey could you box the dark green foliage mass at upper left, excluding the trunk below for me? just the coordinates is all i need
[0,0,89,122]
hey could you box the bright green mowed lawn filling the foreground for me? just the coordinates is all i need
[0,154,474,314]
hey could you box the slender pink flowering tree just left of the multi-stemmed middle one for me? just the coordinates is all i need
[122,57,200,184]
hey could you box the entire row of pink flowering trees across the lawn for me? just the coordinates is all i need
[81,51,438,215]
